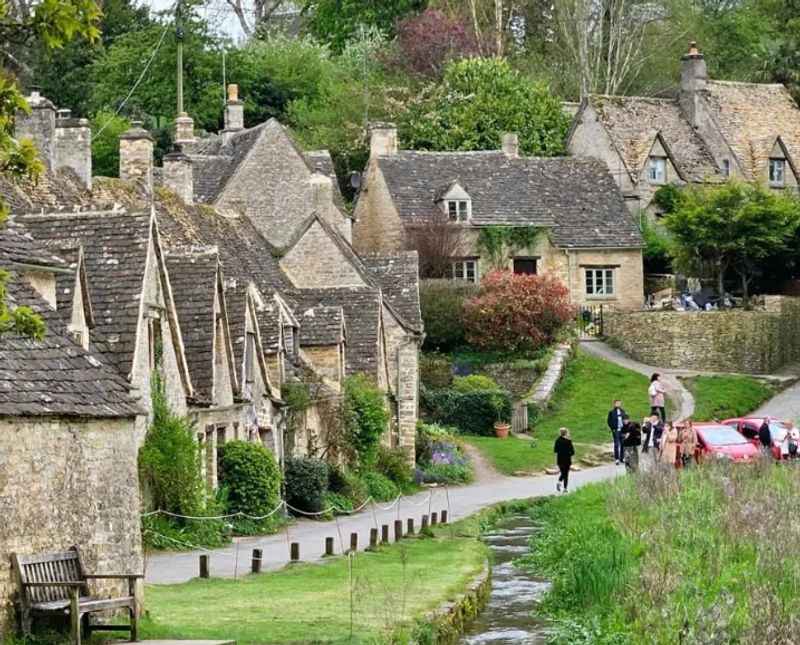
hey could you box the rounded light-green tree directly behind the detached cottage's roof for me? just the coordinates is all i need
[399,58,569,156]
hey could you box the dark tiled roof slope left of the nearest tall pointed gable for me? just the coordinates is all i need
[16,212,150,376]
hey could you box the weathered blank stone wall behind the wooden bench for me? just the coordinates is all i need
[0,417,144,641]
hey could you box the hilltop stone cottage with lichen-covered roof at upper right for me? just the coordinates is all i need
[567,43,800,216]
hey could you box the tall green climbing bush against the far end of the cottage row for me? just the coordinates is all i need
[343,374,389,466]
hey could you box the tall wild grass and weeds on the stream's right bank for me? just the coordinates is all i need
[522,462,800,645]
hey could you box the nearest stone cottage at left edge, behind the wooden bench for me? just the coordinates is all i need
[0,229,146,639]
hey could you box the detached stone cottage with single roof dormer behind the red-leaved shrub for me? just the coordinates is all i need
[353,125,643,309]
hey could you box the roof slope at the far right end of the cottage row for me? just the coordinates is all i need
[361,251,423,331]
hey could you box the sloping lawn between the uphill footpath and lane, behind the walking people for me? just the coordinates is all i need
[464,350,650,474]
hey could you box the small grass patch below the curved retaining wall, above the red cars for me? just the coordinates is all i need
[683,376,780,421]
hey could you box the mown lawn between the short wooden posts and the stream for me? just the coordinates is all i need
[143,516,487,645]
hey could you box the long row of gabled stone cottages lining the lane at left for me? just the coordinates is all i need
[0,90,422,633]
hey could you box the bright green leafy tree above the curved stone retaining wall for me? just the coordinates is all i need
[664,182,800,303]
